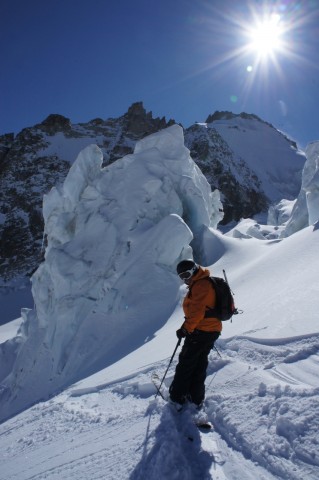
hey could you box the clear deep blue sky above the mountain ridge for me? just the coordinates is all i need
[0,0,319,146]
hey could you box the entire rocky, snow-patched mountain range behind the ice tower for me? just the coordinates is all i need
[0,102,304,293]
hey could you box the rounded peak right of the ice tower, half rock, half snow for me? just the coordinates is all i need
[185,112,305,223]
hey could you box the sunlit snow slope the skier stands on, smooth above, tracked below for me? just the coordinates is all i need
[0,224,319,480]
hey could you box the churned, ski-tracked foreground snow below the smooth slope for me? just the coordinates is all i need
[0,334,319,480]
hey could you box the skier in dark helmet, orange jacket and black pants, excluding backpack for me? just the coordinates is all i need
[169,260,222,410]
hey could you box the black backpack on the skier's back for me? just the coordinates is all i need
[205,270,239,322]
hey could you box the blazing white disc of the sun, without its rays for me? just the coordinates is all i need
[247,14,283,60]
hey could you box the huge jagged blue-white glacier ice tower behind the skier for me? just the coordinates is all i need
[0,125,222,418]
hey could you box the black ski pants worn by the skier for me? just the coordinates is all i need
[169,330,220,405]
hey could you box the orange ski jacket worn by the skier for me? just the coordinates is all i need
[183,267,223,333]
